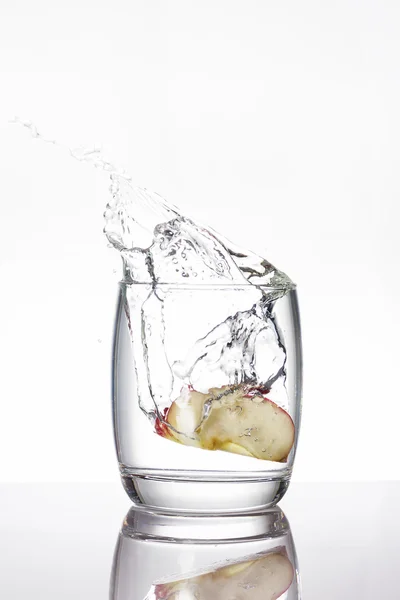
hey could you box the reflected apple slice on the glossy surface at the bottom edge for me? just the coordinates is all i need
[154,552,294,600]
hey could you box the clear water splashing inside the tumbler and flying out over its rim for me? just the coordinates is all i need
[13,118,295,460]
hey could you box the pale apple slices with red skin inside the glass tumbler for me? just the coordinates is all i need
[159,385,295,462]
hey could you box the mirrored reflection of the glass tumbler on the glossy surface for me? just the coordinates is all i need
[110,508,301,600]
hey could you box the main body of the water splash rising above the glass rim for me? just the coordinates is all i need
[104,172,295,292]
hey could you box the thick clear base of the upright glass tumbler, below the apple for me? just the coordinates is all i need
[121,468,290,515]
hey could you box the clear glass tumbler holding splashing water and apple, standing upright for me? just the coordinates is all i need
[113,283,302,514]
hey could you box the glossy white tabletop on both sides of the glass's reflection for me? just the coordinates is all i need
[0,483,400,600]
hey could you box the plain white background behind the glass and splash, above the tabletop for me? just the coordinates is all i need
[0,0,400,481]
